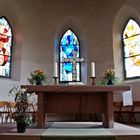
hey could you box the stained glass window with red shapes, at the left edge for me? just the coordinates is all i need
[0,17,12,77]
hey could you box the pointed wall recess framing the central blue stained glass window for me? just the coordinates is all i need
[54,17,87,83]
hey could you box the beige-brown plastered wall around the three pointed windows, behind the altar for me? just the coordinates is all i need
[0,0,140,100]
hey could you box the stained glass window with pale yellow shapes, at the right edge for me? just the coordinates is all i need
[123,19,140,78]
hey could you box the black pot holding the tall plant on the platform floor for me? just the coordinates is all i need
[17,121,27,133]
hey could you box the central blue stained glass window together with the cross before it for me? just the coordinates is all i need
[60,29,83,82]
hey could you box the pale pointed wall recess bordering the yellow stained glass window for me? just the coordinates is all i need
[113,6,140,80]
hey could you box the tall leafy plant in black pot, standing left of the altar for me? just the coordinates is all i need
[9,86,32,133]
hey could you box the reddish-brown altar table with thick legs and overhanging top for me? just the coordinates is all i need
[22,85,130,128]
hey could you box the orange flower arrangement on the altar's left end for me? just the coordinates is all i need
[28,70,46,85]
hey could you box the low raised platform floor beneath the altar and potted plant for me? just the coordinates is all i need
[0,122,140,140]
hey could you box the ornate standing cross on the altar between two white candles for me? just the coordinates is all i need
[63,50,84,81]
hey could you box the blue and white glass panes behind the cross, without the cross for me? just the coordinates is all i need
[60,30,80,82]
